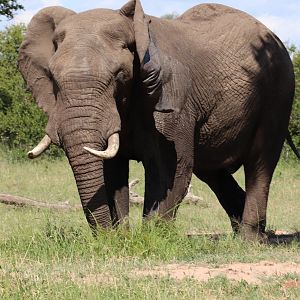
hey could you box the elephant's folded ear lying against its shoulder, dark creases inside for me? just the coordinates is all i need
[120,0,189,112]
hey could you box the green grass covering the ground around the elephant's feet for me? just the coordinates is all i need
[0,149,300,299]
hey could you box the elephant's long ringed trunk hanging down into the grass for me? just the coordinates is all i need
[58,76,121,230]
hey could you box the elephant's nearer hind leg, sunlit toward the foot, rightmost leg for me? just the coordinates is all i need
[241,120,285,242]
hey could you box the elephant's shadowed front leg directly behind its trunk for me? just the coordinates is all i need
[104,158,129,225]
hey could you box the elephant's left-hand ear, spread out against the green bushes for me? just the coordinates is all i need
[18,6,75,138]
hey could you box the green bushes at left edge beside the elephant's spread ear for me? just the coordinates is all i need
[0,25,63,158]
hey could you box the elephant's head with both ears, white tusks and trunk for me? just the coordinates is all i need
[18,0,184,228]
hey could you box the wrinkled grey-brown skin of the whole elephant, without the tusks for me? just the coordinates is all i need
[19,1,294,240]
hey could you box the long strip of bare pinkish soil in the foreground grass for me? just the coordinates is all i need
[132,261,300,287]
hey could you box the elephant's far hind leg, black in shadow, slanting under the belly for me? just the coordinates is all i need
[194,170,245,232]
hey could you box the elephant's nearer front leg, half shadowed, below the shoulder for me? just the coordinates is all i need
[143,155,193,220]
